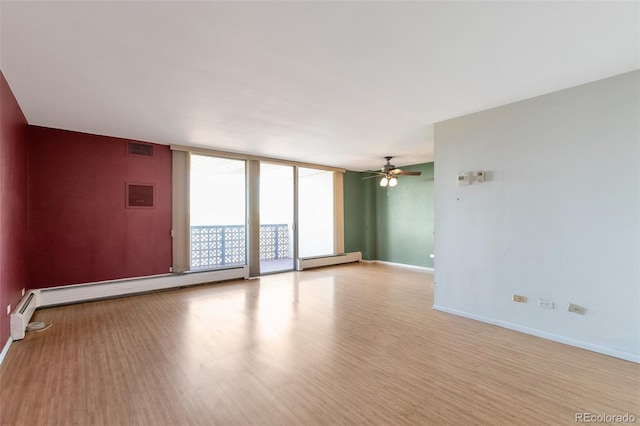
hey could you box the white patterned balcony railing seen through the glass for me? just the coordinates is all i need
[191,223,289,270]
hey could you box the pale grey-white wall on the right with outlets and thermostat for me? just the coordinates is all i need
[434,71,640,362]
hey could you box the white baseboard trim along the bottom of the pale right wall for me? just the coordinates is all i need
[433,305,640,363]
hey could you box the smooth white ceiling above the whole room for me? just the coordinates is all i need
[0,0,640,170]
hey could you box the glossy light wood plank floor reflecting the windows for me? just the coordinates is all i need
[0,264,640,425]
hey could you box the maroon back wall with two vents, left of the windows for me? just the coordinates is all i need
[29,126,172,288]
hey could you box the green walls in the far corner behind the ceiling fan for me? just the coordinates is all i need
[344,163,434,268]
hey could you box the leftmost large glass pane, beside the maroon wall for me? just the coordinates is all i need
[189,155,247,271]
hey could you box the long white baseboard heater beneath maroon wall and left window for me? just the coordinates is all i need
[38,265,249,307]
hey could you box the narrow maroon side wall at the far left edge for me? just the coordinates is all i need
[0,71,28,344]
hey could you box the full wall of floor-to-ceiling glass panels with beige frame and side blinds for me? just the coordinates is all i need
[173,150,343,276]
